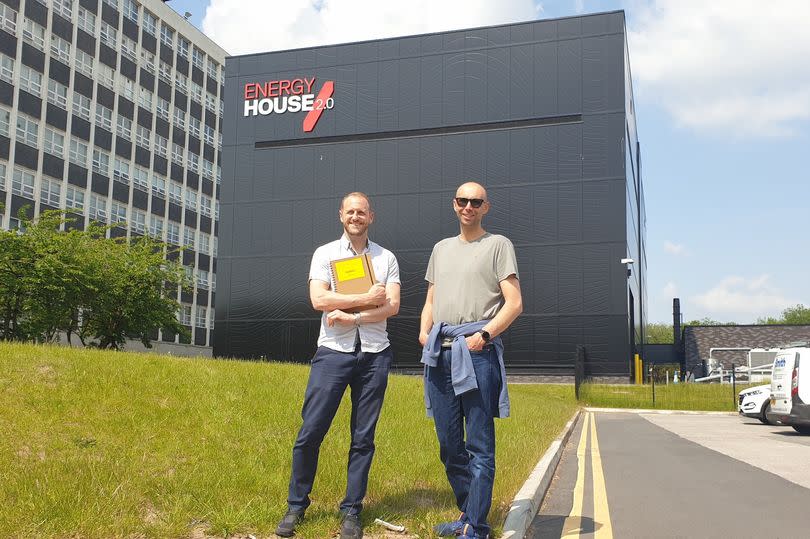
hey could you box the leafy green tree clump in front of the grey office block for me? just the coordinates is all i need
[0,211,187,349]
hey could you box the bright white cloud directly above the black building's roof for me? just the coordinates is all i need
[202,0,537,54]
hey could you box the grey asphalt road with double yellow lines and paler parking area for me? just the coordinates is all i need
[526,412,810,539]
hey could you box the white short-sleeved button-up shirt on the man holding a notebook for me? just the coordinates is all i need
[309,234,400,353]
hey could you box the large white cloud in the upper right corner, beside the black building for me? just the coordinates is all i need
[628,0,810,136]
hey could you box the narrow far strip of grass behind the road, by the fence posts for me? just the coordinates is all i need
[579,383,758,412]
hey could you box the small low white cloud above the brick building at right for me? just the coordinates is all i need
[690,275,801,323]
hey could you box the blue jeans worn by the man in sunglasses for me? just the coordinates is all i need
[427,347,503,537]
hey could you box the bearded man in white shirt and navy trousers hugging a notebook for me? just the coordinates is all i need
[276,193,400,539]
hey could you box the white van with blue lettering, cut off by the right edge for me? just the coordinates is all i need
[767,343,810,434]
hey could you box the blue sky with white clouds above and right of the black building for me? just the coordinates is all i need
[168,0,810,324]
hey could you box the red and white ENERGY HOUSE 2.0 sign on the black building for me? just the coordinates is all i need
[243,77,335,133]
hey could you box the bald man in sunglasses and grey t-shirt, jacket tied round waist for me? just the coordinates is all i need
[419,182,523,539]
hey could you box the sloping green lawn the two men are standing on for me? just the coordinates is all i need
[0,343,577,538]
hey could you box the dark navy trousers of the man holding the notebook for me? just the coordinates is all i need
[287,346,394,514]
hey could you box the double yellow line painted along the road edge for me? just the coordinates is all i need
[562,412,613,539]
